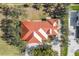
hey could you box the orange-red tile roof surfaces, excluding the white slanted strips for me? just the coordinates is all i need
[21,19,59,43]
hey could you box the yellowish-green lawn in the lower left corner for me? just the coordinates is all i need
[0,39,20,56]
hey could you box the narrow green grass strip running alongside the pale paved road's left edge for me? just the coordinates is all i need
[61,15,68,56]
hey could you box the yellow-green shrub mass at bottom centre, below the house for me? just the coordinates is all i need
[30,45,58,56]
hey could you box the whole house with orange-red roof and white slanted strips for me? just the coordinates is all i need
[21,18,60,46]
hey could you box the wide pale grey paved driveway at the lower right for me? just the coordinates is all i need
[68,29,79,56]
